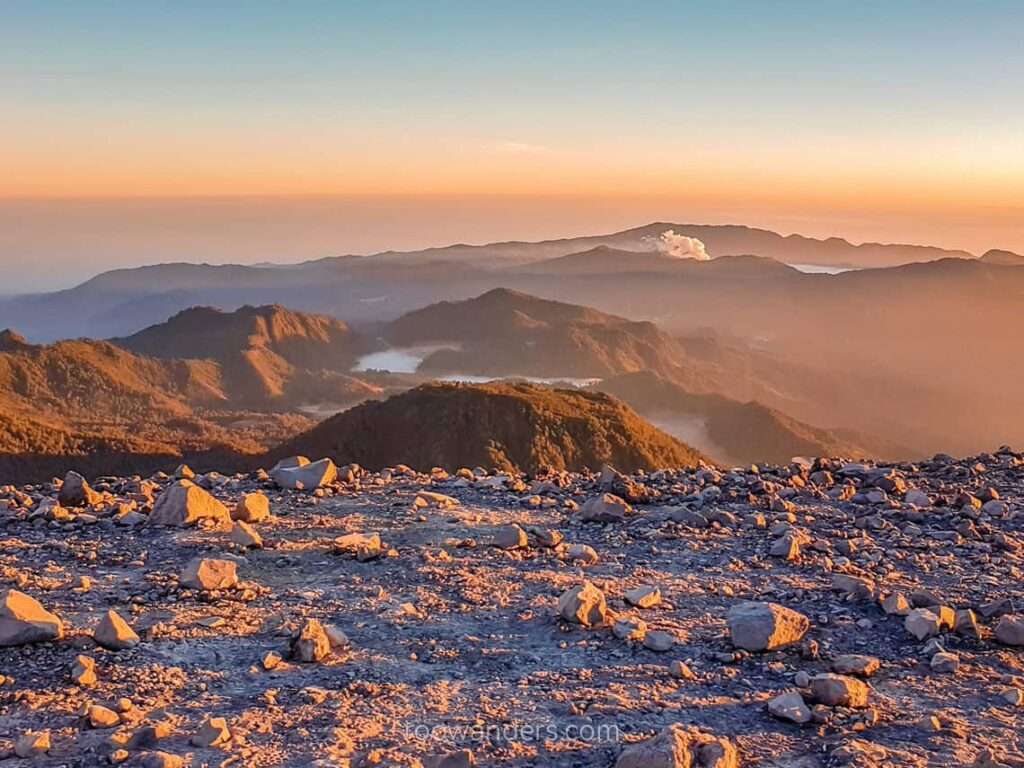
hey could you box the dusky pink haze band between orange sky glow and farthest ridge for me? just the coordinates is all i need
[0,196,1024,295]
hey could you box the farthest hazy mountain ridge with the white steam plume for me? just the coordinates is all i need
[0,222,1013,341]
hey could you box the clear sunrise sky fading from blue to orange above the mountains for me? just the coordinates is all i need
[0,0,1024,293]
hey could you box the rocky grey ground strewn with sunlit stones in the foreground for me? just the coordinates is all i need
[0,450,1024,768]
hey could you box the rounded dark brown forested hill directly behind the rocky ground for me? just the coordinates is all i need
[266,383,701,471]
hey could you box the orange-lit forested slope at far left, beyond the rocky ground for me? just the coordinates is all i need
[0,341,311,484]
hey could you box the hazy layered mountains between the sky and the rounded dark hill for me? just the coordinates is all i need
[0,217,1024,479]
